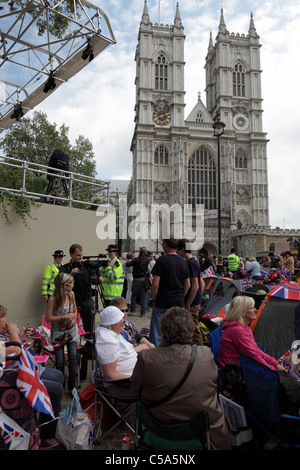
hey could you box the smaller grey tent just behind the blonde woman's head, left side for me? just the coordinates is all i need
[203,278,241,317]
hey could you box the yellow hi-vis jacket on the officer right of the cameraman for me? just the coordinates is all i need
[100,258,125,301]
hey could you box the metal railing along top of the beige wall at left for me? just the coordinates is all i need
[0,156,110,207]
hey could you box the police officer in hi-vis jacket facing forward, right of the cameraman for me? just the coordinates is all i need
[99,245,125,307]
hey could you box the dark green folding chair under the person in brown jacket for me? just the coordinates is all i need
[135,401,210,450]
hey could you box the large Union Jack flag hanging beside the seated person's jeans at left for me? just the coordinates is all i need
[17,348,55,418]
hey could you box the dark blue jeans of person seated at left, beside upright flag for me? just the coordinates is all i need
[40,368,64,439]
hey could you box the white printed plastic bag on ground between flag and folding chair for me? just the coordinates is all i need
[56,388,93,450]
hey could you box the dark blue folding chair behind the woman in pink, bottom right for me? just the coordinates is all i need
[239,354,300,449]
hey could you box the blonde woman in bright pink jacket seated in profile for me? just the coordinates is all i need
[218,295,283,370]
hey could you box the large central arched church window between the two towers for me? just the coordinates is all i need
[188,147,217,210]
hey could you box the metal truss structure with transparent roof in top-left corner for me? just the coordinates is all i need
[0,0,116,132]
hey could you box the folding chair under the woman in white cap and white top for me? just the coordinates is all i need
[93,334,138,443]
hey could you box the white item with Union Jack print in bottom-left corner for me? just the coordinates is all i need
[0,408,30,450]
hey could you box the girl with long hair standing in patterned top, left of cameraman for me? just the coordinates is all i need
[46,273,79,392]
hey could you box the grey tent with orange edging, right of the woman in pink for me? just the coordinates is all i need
[250,292,298,359]
